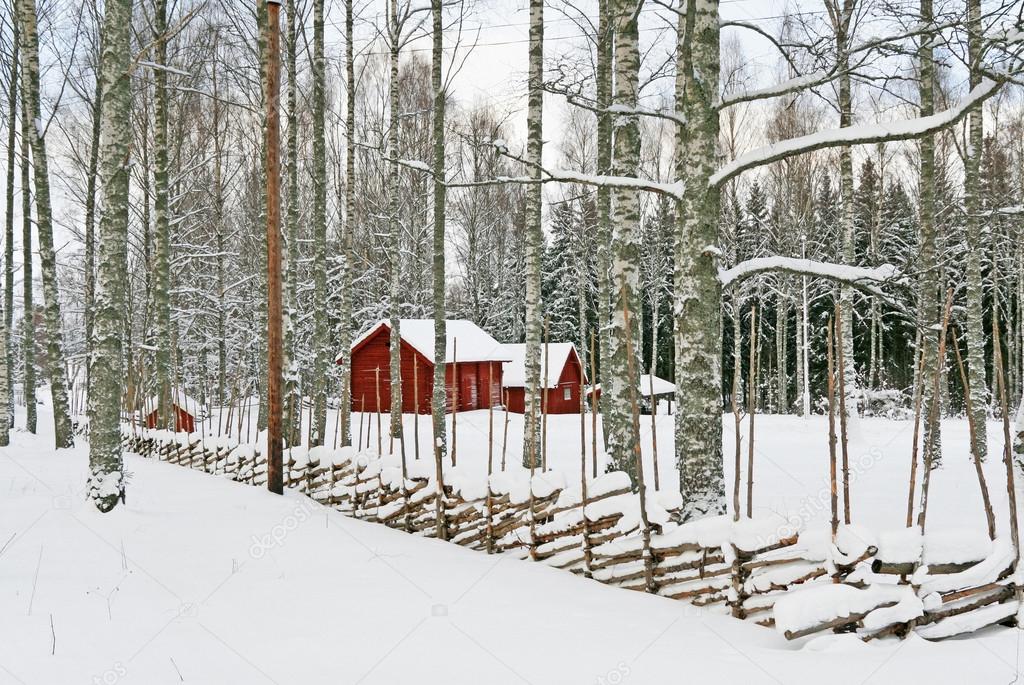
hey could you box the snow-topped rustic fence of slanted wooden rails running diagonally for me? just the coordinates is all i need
[122,424,1020,640]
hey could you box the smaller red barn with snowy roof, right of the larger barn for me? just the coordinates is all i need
[502,343,587,414]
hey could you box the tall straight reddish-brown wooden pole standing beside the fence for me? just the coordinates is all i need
[263,0,284,495]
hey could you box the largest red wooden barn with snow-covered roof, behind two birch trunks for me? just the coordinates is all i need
[336,318,507,414]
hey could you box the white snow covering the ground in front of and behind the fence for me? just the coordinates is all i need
[0,403,1020,685]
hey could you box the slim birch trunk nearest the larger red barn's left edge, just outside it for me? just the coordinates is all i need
[338,0,356,446]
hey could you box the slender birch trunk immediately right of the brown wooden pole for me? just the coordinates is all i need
[282,0,299,446]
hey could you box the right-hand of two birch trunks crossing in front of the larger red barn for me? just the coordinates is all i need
[432,0,448,460]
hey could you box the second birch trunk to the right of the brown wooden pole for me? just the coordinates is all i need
[309,0,329,445]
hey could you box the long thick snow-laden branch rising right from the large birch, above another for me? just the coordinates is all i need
[709,79,1002,186]
